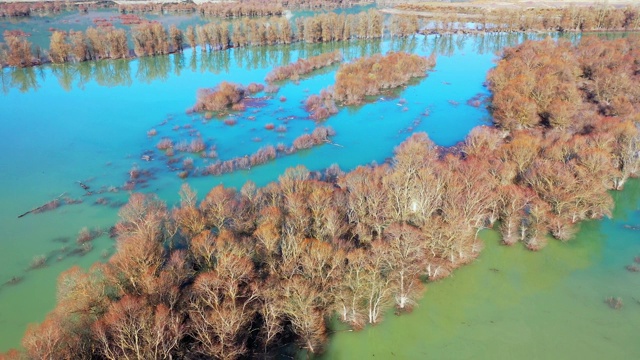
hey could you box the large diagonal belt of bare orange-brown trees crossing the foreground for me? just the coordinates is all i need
[2,37,640,359]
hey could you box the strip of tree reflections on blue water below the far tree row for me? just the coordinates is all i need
[0,33,596,94]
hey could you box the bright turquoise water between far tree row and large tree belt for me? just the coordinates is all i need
[0,31,560,351]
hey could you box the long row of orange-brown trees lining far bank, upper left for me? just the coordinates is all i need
[0,10,392,67]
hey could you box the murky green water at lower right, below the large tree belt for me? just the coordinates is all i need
[321,180,640,359]
